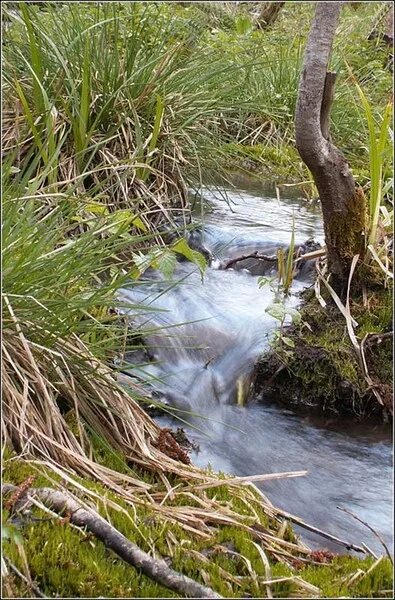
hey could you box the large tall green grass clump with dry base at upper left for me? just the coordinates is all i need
[3,2,262,218]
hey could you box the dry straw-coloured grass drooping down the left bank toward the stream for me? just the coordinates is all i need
[2,296,332,580]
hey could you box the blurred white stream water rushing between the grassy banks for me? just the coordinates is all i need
[123,176,393,552]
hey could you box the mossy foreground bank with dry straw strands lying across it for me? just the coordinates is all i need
[3,453,391,598]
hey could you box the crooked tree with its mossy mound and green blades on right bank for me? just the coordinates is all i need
[259,3,393,420]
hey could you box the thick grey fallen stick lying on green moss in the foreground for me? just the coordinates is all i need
[2,484,222,598]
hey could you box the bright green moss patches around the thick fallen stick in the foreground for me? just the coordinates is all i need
[3,452,391,598]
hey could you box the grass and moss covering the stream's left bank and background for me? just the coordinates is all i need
[2,2,392,597]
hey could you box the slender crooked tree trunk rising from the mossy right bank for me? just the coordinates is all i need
[295,2,366,291]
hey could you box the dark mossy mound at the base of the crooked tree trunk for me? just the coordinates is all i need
[257,289,392,419]
